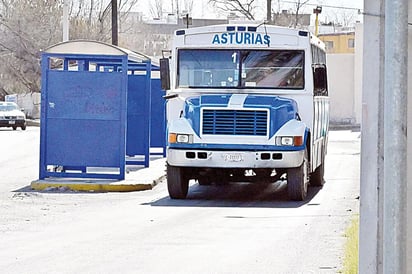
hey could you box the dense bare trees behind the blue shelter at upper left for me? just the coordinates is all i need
[0,0,138,93]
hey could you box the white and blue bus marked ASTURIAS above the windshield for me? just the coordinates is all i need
[160,24,329,201]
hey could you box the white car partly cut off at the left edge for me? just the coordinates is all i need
[0,102,26,130]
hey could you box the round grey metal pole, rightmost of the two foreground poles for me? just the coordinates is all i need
[383,0,408,274]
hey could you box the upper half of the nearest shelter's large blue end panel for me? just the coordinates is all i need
[47,71,122,120]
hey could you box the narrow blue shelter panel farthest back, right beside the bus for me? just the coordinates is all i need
[150,79,166,153]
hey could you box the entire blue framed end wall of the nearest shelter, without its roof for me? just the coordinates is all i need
[40,54,127,179]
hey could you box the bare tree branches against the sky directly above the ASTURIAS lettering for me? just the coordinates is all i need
[209,0,257,20]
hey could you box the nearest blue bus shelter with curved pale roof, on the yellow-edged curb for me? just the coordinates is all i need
[40,40,161,180]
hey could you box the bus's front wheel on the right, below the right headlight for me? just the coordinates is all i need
[287,150,309,201]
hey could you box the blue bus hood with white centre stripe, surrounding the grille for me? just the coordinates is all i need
[183,94,298,138]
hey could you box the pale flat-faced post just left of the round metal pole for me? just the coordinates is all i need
[359,0,385,274]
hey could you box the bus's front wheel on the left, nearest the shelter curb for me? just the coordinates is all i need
[167,165,189,199]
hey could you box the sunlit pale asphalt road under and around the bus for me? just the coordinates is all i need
[0,127,360,273]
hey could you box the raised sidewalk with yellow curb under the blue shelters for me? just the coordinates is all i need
[30,158,166,192]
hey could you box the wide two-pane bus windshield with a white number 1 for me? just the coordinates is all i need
[177,49,304,89]
